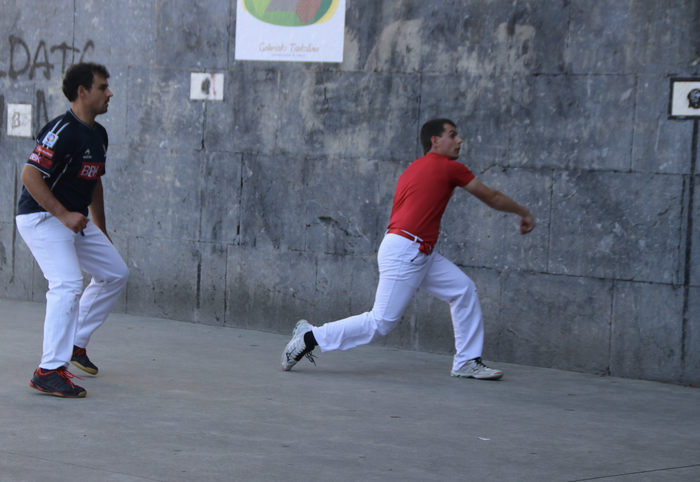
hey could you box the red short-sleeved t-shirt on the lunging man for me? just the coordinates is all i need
[389,153,475,246]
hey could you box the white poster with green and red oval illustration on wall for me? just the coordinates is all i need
[236,0,345,62]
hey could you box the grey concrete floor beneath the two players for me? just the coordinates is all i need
[0,300,700,482]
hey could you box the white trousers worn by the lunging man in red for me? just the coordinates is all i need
[313,234,484,370]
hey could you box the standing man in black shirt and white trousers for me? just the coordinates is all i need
[16,63,129,398]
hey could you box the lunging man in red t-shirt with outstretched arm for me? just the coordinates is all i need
[282,119,535,380]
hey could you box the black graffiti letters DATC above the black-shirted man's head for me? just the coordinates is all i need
[0,35,95,80]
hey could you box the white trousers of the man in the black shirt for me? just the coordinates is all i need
[16,213,129,370]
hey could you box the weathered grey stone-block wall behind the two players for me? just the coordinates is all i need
[0,0,700,384]
